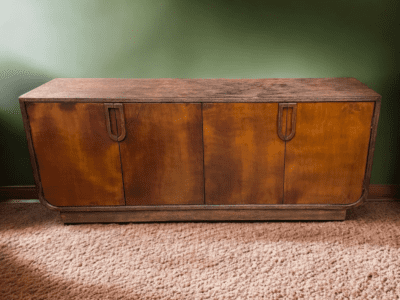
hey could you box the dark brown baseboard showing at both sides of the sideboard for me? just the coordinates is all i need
[0,184,400,201]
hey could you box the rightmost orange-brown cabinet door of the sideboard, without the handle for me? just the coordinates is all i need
[284,102,374,204]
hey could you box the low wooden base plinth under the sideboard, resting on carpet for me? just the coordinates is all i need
[60,209,346,224]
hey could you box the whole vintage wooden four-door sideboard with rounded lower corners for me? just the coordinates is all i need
[19,78,381,224]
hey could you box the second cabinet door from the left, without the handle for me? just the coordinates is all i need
[117,103,204,205]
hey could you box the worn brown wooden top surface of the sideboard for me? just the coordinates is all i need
[19,77,381,102]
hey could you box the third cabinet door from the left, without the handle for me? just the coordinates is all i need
[203,103,286,205]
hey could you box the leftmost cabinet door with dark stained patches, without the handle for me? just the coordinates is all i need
[26,102,125,206]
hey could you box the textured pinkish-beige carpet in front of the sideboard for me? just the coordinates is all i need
[0,202,400,300]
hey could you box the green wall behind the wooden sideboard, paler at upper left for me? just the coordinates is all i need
[0,0,400,186]
